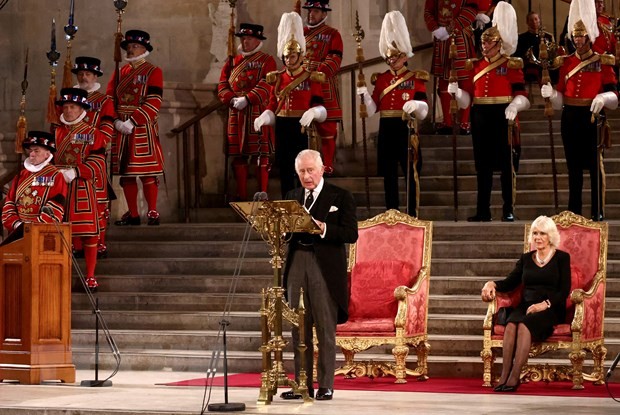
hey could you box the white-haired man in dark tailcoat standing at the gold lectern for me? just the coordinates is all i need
[280,150,357,400]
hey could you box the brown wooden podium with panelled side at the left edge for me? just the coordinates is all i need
[0,223,75,384]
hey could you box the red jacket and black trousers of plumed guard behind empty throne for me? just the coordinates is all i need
[371,67,429,217]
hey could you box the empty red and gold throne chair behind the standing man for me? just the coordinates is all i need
[336,210,432,383]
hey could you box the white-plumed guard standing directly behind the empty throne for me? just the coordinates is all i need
[357,11,429,217]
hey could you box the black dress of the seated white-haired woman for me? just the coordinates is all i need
[495,249,571,341]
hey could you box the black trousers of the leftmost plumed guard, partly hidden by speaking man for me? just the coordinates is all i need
[275,117,308,199]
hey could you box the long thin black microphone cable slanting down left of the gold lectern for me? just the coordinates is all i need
[200,192,268,415]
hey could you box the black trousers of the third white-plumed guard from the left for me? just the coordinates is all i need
[470,104,514,217]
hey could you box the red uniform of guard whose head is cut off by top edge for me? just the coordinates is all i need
[424,0,478,129]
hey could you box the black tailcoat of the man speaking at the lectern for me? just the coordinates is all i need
[284,181,357,324]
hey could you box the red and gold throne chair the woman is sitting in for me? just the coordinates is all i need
[480,211,608,389]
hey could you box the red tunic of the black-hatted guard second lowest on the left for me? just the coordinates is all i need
[54,122,106,236]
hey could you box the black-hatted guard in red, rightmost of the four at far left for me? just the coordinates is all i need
[107,30,164,226]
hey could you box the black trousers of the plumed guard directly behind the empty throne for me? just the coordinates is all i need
[377,117,422,217]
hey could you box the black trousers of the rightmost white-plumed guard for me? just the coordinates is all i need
[562,105,605,216]
